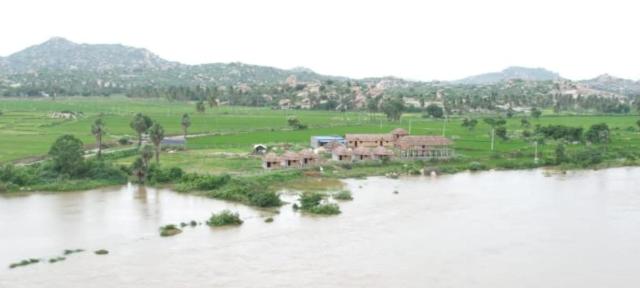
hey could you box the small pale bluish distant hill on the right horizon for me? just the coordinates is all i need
[453,66,562,85]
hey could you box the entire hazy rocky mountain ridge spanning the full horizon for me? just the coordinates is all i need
[0,37,640,97]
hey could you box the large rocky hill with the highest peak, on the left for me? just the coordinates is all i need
[0,37,346,87]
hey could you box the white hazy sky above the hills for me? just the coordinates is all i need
[0,0,640,80]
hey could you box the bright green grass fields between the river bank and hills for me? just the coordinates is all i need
[0,97,640,173]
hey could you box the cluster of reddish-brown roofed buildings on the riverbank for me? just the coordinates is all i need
[254,128,455,169]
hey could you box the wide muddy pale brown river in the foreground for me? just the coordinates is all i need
[0,168,640,288]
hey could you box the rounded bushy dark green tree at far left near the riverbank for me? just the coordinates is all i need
[49,135,84,176]
